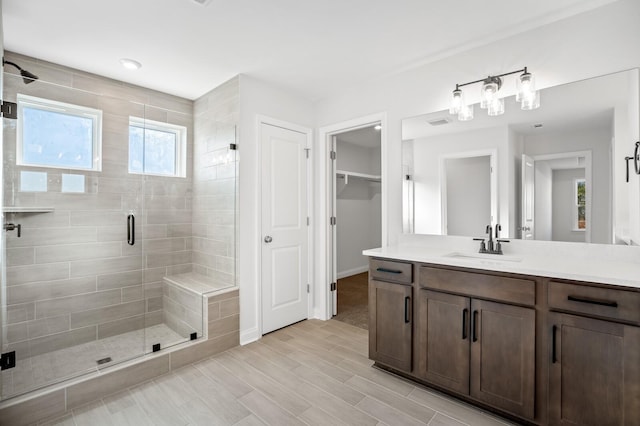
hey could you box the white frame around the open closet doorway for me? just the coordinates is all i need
[313,112,388,320]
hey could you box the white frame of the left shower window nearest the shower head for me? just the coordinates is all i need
[16,93,102,172]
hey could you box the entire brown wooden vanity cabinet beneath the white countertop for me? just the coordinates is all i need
[369,258,640,426]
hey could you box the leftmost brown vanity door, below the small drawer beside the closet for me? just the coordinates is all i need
[369,280,413,372]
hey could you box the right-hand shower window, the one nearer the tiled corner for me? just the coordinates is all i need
[129,117,187,177]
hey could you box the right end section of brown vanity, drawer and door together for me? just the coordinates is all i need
[548,281,640,425]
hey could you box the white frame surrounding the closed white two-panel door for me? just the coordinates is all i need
[254,114,315,338]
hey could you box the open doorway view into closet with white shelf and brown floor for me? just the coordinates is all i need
[331,123,382,329]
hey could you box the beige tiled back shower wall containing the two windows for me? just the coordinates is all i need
[3,52,193,360]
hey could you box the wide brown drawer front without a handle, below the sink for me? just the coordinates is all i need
[418,266,536,306]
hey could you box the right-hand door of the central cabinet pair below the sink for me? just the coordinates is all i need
[470,299,536,419]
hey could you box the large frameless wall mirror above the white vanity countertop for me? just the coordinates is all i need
[402,69,640,244]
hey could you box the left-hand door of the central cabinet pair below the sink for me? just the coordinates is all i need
[416,289,471,395]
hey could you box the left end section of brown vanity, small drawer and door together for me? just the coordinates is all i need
[369,260,413,372]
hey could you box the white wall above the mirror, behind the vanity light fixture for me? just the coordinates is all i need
[318,0,640,248]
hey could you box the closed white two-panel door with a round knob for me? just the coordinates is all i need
[260,123,308,334]
